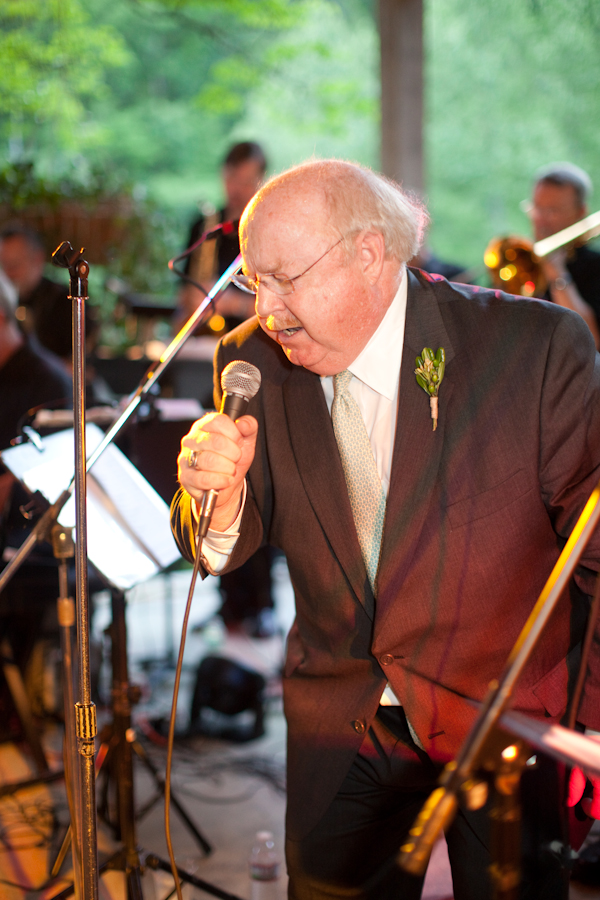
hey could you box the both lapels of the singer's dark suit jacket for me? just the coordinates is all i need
[282,272,454,616]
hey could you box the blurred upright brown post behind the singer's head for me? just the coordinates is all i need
[379,0,425,194]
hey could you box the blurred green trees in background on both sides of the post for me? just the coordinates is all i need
[0,0,600,292]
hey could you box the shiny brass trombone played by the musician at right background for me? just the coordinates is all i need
[483,211,600,297]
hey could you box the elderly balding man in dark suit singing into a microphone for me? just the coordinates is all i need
[173,160,600,900]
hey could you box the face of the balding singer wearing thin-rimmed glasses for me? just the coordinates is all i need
[242,187,383,375]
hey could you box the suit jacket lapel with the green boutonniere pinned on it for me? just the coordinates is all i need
[377,271,454,616]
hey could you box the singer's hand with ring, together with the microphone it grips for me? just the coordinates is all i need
[178,360,260,538]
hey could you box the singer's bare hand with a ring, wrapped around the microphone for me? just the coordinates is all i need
[177,413,258,531]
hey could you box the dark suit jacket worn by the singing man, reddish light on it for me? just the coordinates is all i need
[173,270,600,838]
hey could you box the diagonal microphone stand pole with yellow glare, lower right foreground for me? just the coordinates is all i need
[398,481,600,900]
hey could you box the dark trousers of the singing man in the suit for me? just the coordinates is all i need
[286,707,568,900]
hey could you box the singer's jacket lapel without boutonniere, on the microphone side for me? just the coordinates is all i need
[282,367,374,616]
